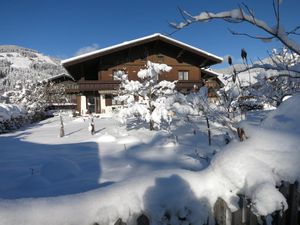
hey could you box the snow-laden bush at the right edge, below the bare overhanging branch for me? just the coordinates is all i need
[238,48,300,106]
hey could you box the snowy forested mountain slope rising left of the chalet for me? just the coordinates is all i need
[0,45,66,93]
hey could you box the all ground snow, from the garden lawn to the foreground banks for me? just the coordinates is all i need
[0,95,300,225]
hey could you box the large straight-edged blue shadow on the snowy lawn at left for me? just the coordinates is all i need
[0,131,105,199]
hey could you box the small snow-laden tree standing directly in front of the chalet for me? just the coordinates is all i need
[116,61,176,130]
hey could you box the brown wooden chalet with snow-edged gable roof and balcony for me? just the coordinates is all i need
[62,33,222,113]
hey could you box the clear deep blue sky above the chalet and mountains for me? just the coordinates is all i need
[0,0,300,68]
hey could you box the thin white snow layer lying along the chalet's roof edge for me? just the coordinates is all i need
[61,33,223,65]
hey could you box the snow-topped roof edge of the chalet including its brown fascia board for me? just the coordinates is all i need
[61,33,223,66]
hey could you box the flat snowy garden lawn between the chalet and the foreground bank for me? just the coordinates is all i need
[0,113,223,198]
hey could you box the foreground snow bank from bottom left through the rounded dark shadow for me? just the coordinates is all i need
[0,170,216,225]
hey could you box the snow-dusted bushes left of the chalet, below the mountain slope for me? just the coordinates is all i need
[0,81,66,132]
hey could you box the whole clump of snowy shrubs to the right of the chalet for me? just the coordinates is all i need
[219,48,300,111]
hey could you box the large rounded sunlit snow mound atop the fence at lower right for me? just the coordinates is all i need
[211,123,300,215]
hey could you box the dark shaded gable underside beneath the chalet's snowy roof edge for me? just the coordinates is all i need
[64,39,223,80]
